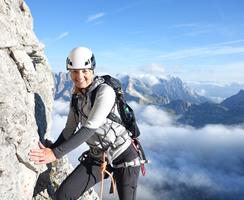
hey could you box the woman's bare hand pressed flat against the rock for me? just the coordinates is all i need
[28,142,57,165]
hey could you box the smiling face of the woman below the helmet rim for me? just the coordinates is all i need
[70,69,93,90]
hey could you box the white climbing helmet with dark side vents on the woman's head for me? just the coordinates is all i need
[66,47,96,70]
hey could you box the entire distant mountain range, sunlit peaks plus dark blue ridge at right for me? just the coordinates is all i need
[54,72,244,127]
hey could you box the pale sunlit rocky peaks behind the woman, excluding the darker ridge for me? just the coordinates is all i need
[54,72,209,106]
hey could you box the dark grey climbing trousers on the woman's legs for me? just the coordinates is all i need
[55,159,140,200]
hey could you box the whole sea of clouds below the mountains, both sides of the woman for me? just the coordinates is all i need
[52,101,244,200]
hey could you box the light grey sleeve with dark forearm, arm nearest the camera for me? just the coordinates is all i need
[53,85,115,158]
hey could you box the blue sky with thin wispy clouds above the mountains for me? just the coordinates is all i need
[25,0,244,83]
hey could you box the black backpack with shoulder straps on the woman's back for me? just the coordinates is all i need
[91,75,140,139]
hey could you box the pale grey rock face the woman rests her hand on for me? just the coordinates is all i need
[0,0,54,200]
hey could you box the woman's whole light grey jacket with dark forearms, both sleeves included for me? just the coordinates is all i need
[53,77,131,163]
